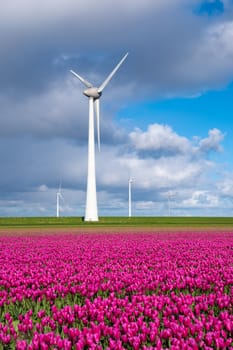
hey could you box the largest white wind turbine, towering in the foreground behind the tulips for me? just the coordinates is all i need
[70,53,128,221]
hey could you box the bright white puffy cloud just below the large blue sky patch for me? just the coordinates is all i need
[97,124,222,198]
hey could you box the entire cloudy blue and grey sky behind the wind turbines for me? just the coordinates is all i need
[0,0,233,216]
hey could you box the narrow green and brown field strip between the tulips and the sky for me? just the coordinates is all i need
[0,217,233,230]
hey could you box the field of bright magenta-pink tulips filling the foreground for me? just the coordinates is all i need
[0,231,233,350]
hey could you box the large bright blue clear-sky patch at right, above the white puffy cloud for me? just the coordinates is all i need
[117,84,233,154]
